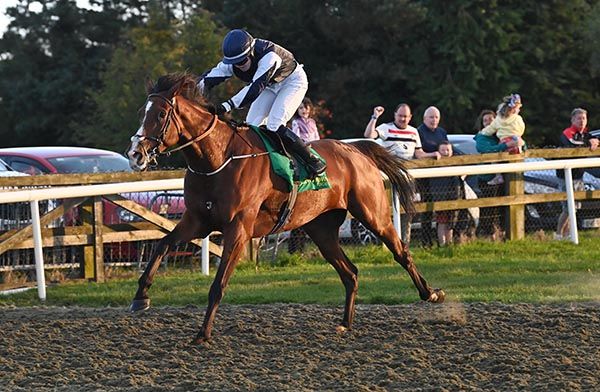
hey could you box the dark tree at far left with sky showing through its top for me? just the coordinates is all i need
[0,0,145,145]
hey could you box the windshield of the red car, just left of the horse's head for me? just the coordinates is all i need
[48,155,131,173]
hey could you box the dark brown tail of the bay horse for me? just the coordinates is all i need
[350,140,415,214]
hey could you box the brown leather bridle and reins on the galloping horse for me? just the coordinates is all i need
[131,93,217,164]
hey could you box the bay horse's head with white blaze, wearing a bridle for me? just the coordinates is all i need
[127,73,213,171]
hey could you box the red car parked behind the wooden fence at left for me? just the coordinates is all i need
[0,147,185,259]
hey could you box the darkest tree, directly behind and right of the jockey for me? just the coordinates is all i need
[212,0,424,138]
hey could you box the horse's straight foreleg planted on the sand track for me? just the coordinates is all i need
[192,225,250,344]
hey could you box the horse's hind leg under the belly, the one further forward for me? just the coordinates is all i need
[303,210,358,332]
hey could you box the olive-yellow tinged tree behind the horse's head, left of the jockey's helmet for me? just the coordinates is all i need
[73,5,223,151]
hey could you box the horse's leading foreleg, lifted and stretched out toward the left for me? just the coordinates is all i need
[130,213,200,312]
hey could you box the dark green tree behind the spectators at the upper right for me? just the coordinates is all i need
[407,0,599,145]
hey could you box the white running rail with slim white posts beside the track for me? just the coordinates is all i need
[0,158,600,300]
